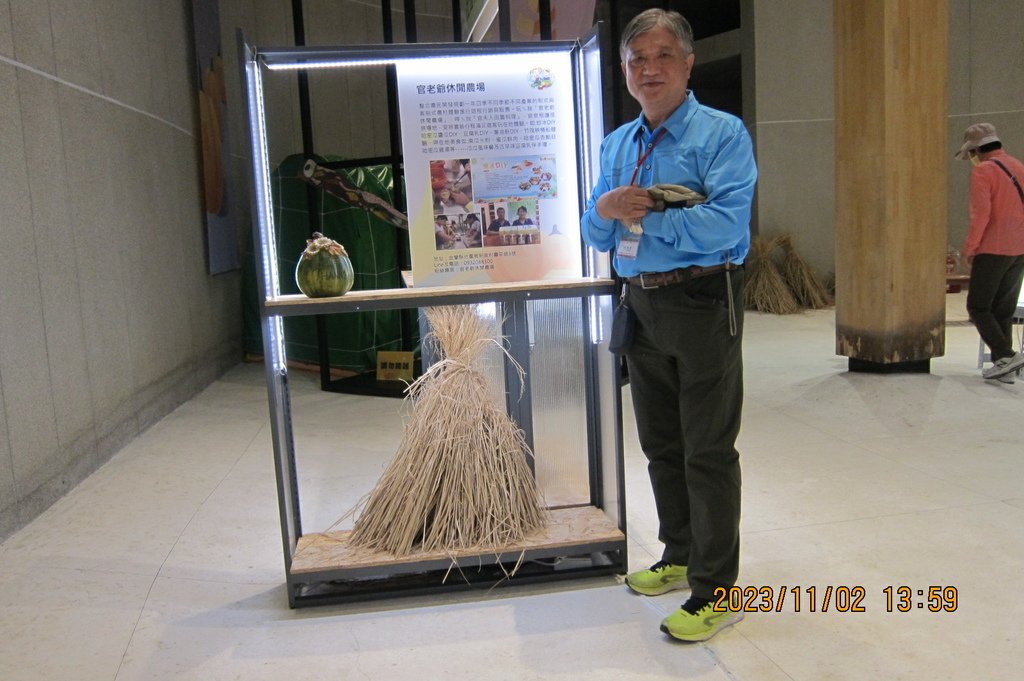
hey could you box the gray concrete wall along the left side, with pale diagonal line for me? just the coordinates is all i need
[0,0,241,538]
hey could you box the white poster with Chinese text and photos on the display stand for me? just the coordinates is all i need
[396,51,583,286]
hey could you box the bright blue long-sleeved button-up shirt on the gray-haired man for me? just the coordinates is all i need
[581,92,758,276]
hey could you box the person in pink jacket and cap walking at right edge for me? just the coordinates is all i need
[956,123,1024,383]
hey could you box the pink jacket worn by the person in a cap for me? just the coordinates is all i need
[964,150,1024,257]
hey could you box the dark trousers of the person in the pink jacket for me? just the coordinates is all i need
[967,253,1024,361]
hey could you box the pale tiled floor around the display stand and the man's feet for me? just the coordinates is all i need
[0,294,1024,681]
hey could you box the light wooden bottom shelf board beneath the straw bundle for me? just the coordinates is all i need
[291,506,626,576]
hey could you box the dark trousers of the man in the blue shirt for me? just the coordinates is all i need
[626,269,743,599]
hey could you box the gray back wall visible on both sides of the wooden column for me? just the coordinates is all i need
[745,0,1024,274]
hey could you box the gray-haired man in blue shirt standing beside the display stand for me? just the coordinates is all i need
[581,9,757,641]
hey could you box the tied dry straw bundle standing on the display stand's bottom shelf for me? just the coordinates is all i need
[349,306,547,556]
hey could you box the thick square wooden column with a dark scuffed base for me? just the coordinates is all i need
[833,0,951,372]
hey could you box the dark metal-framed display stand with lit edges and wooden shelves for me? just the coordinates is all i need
[239,32,627,607]
